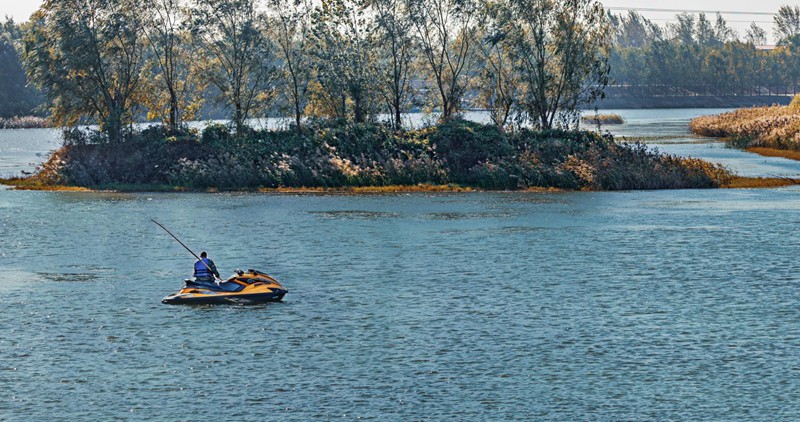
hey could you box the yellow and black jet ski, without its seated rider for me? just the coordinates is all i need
[161,270,289,305]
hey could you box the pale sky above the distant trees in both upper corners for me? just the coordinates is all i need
[0,0,800,41]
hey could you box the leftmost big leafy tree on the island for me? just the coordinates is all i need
[24,0,146,142]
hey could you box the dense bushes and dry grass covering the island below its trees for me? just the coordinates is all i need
[4,120,731,192]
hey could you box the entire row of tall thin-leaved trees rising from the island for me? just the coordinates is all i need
[20,0,610,137]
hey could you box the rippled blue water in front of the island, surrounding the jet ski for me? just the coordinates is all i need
[0,110,800,421]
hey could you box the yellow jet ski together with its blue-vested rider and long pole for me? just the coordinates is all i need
[151,220,288,305]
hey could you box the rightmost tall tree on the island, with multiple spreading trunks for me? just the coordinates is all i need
[497,0,611,130]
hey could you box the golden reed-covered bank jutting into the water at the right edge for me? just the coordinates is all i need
[690,95,800,151]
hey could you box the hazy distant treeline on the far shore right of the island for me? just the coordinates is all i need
[609,6,800,97]
